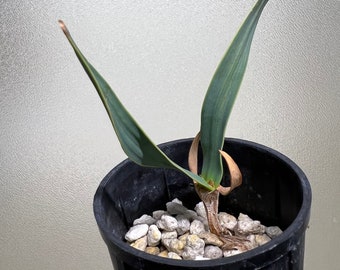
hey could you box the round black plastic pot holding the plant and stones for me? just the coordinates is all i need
[94,139,312,270]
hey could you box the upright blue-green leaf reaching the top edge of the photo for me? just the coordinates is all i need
[200,0,268,187]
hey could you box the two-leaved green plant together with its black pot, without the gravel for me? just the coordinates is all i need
[59,0,311,269]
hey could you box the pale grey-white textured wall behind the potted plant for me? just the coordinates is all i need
[0,0,340,270]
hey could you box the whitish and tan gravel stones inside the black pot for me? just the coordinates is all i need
[125,199,282,260]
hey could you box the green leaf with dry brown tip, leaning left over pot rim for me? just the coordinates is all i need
[59,21,214,190]
